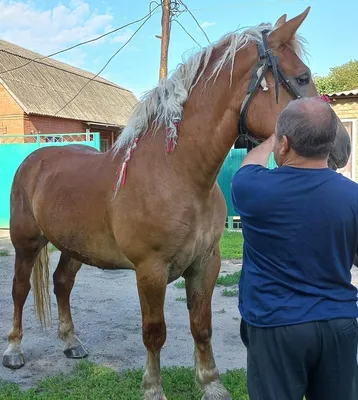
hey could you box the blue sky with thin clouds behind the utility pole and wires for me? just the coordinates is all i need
[0,0,358,97]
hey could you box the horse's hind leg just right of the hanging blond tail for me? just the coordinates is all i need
[53,253,88,358]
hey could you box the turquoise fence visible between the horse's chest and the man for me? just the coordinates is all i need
[218,149,277,228]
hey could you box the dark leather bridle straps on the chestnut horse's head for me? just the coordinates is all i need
[235,29,302,151]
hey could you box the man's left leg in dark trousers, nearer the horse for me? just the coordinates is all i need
[241,322,319,400]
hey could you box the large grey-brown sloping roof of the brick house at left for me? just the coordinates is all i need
[0,40,138,126]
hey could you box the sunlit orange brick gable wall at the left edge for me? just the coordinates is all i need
[0,85,24,135]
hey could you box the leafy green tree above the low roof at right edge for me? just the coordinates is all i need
[314,60,358,94]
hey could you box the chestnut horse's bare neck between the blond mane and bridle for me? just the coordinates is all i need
[173,80,243,190]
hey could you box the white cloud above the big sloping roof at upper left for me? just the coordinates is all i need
[0,0,114,66]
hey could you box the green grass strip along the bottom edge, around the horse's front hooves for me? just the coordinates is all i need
[0,360,249,400]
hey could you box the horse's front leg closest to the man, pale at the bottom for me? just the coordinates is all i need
[185,249,231,400]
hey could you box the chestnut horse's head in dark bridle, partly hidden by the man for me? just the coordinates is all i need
[239,7,350,169]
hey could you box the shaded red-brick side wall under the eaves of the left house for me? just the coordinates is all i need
[24,115,86,135]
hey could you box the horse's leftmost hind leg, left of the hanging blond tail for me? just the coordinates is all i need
[3,234,47,369]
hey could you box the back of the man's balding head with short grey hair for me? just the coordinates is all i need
[276,97,338,159]
